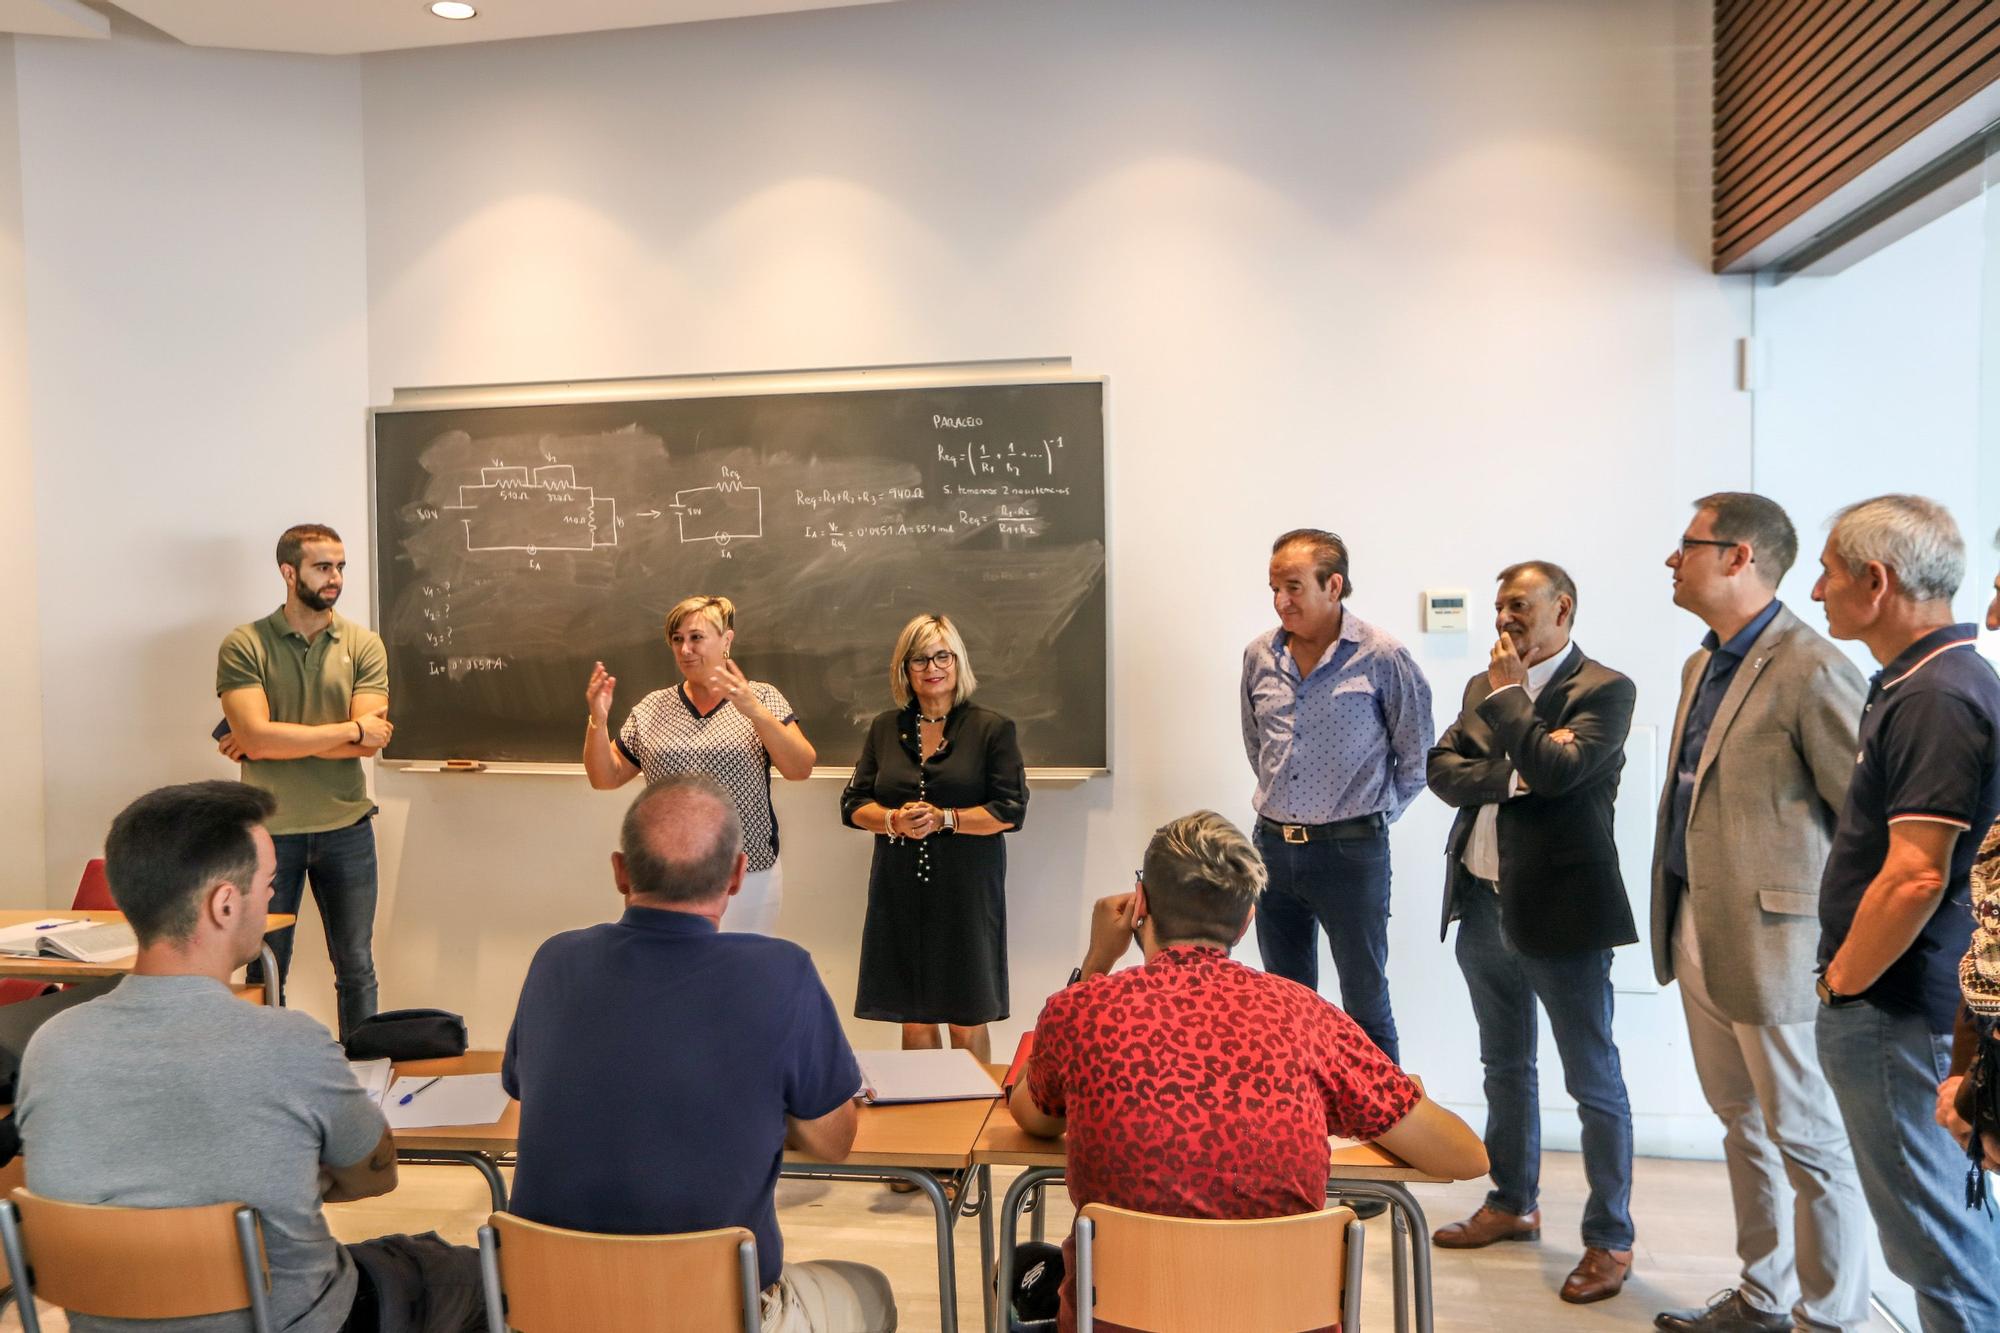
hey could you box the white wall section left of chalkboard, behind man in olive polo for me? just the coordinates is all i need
[16,18,368,967]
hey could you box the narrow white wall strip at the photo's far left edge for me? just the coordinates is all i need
[0,38,46,905]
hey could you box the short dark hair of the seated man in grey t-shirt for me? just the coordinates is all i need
[104,781,278,945]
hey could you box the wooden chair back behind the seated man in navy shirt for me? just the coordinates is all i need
[480,1213,762,1333]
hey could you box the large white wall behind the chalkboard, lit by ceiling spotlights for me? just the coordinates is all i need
[362,0,1748,1149]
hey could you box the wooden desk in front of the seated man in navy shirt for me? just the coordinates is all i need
[394,1051,998,1333]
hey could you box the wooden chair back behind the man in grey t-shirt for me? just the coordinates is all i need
[0,1189,272,1333]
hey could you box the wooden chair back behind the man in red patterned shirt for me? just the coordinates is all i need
[1076,1203,1364,1333]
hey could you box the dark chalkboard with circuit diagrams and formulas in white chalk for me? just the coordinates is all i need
[372,380,1108,769]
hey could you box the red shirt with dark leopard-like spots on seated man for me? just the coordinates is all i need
[1028,947,1422,1333]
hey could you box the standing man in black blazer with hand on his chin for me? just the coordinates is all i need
[1428,560,1638,1305]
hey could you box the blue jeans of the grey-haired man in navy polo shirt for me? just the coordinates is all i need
[1814,1003,2000,1333]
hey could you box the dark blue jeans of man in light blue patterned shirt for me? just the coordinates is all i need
[1256,825,1396,1061]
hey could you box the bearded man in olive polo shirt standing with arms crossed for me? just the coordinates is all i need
[216,522,392,1039]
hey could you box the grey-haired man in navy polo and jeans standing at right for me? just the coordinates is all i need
[1812,494,2000,1333]
